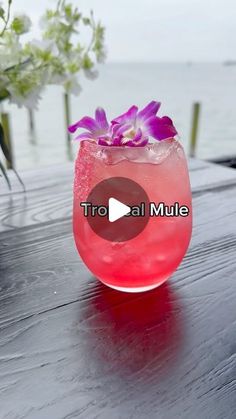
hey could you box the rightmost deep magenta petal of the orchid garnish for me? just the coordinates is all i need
[145,116,177,140]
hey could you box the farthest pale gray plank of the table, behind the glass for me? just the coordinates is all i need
[0,159,236,232]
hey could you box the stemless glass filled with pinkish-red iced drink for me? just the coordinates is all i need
[73,139,192,292]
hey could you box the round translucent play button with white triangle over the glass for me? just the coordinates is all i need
[80,177,149,242]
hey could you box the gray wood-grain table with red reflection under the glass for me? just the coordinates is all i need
[0,160,236,419]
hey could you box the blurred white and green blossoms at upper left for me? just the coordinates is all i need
[0,0,105,187]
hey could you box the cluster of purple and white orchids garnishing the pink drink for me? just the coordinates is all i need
[68,101,177,147]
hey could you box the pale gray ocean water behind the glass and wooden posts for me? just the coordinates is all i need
[0,64,236,170]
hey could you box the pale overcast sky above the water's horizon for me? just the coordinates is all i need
[10,0,236,62]
